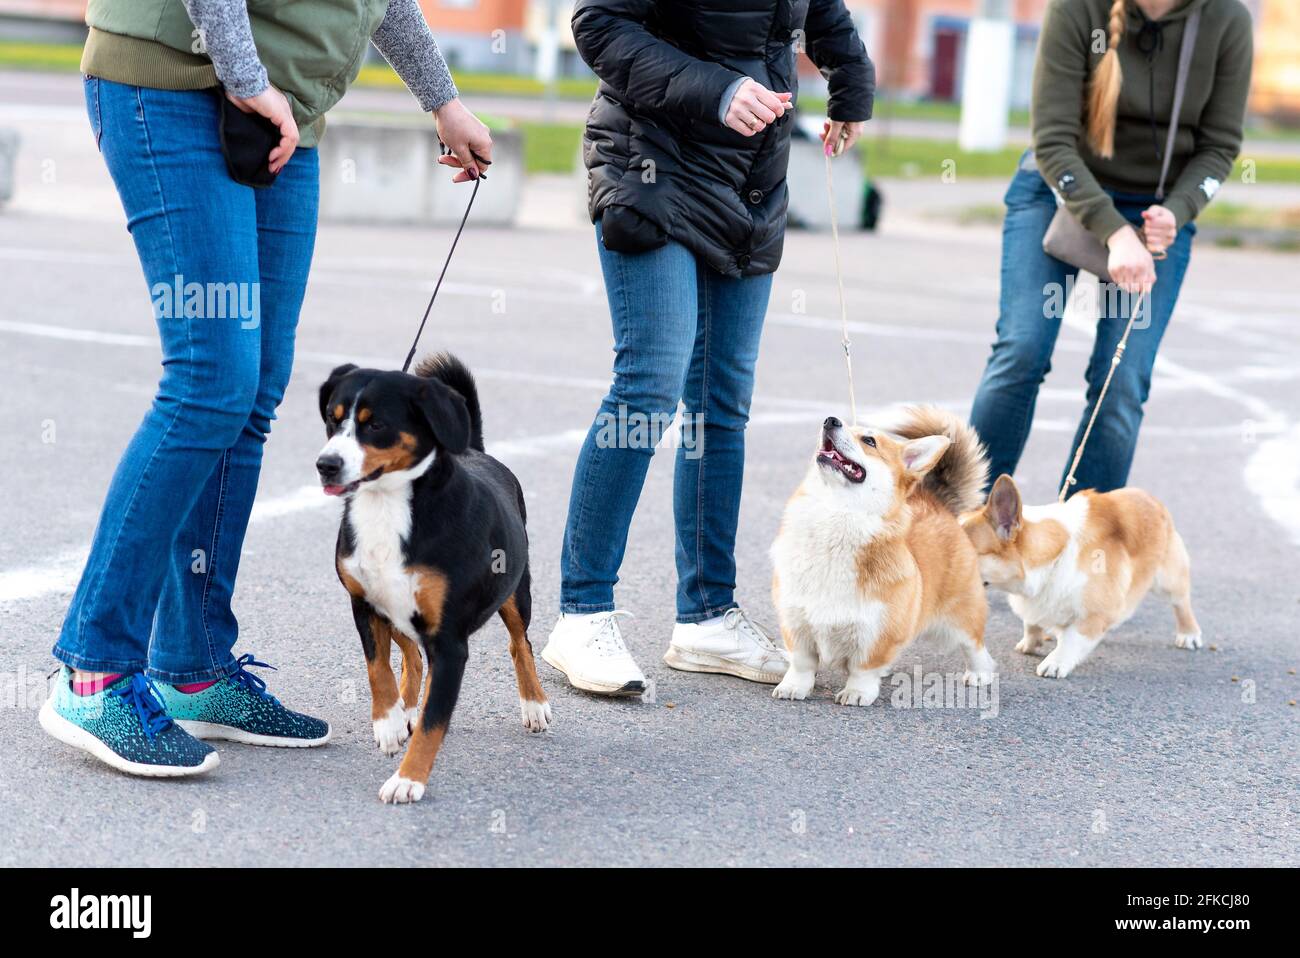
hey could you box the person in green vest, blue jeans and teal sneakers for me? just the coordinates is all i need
[40,0,491,776]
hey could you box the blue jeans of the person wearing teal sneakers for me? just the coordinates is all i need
[55,77,320,682]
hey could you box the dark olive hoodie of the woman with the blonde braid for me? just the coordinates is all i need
[1032,0,1252,242]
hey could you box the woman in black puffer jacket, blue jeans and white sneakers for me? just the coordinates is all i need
[542,0,875,694]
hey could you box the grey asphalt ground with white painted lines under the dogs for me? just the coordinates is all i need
[0,74,1300,866]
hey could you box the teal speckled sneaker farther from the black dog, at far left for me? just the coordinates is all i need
[40,666,221,779]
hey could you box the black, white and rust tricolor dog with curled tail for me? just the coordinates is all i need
[316,354,551,802]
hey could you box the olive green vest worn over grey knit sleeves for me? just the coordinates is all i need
[82,0,389,147]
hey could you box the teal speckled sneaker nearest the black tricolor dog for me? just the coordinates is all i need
[159,655,329,749]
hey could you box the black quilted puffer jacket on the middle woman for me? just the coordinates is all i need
[573,0,875,276]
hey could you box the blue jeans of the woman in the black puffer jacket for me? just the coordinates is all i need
[560,225,772,623]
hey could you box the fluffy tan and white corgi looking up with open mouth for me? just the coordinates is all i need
[772,407,997,706]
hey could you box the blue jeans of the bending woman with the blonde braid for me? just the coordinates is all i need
[971,159,1196,493]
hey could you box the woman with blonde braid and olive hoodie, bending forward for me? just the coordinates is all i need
[971,0,1252,491]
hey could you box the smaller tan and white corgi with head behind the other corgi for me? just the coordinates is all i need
[962,476,1201,679]
